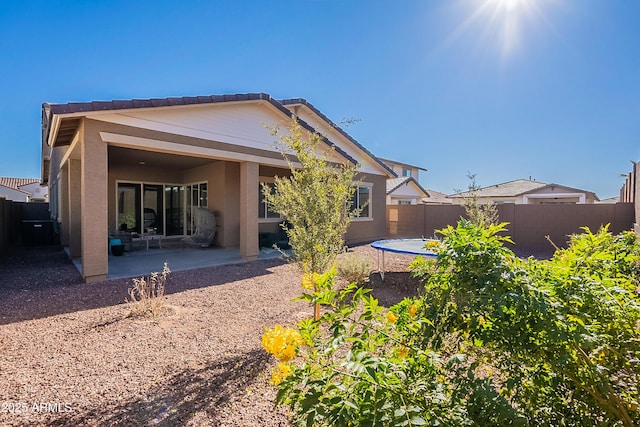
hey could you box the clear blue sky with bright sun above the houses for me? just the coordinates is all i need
[0,0,640,198]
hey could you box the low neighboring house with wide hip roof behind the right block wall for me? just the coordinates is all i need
[447,179,599,205]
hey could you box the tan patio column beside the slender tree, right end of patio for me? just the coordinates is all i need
[240,162,260,261]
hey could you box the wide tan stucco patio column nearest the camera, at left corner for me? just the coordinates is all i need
[81,120,109,283]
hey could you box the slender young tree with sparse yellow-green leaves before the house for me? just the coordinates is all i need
[262,118,357,317]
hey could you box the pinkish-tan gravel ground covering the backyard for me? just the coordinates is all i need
[0,245,418,426]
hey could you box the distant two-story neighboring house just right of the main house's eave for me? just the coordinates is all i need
[380,158,429,205]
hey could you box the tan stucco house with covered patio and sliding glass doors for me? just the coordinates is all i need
[42,93,395,282]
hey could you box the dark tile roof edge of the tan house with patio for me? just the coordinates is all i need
[42,93,396,176]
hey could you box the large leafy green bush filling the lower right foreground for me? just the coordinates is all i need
[264,220,640,426]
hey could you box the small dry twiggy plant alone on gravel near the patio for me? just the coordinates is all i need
[127,262,171,319]
